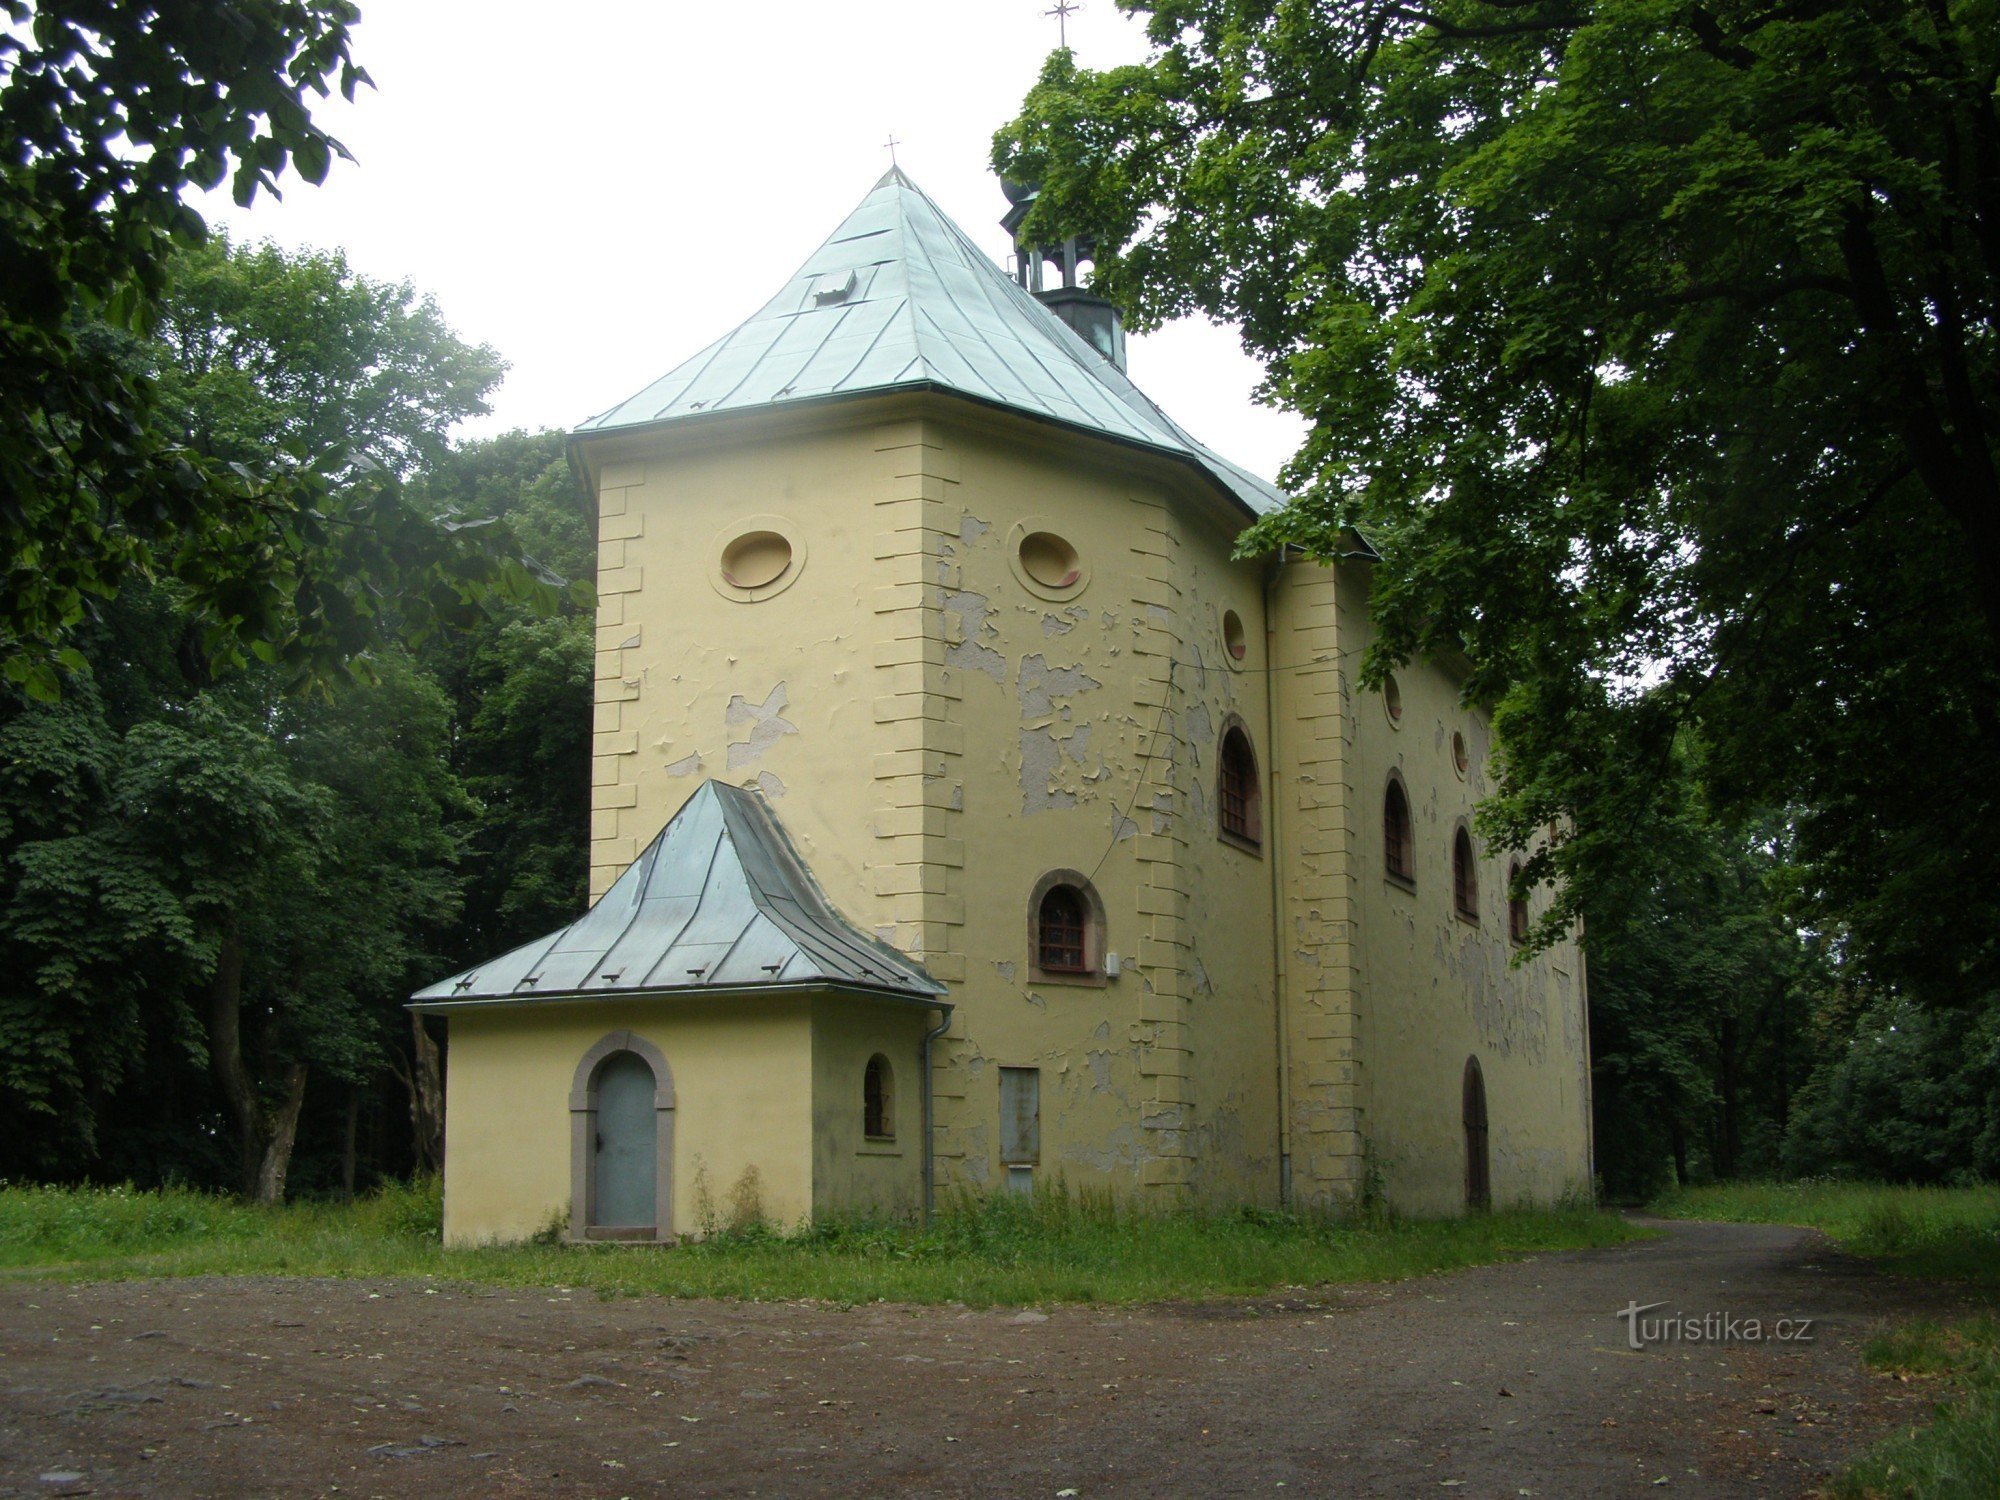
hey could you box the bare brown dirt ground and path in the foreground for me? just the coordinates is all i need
[0,1224,1954,1500]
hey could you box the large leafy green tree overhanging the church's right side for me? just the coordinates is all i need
[996,0,2000,1002]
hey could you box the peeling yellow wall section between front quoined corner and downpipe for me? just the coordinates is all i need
[908,420,1276,1200]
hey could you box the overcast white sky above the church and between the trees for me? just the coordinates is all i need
[202,0,1304,476]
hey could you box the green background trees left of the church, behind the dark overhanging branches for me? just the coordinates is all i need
[0,244,594,1192]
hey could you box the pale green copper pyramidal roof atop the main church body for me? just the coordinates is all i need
[574,168,1284,514]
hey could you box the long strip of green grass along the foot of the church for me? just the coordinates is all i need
[0,1186,1638,1306]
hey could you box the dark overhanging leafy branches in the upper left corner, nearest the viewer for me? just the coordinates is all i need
[0,0,560,698]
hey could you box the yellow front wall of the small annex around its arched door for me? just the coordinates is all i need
[444,996,814,1244]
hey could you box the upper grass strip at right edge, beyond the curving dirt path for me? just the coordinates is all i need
[1652,1182,2000,1286]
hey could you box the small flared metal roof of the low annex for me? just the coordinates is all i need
[410,782,944,1010]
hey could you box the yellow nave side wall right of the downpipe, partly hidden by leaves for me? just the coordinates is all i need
[1282,564,1590,1212]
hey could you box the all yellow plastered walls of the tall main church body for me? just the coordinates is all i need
[568,396,1588,1210]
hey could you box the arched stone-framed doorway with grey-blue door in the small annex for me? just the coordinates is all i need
[570,1032,674,1240]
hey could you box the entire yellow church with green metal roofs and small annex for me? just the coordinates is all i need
[412,170,1590,1244]
